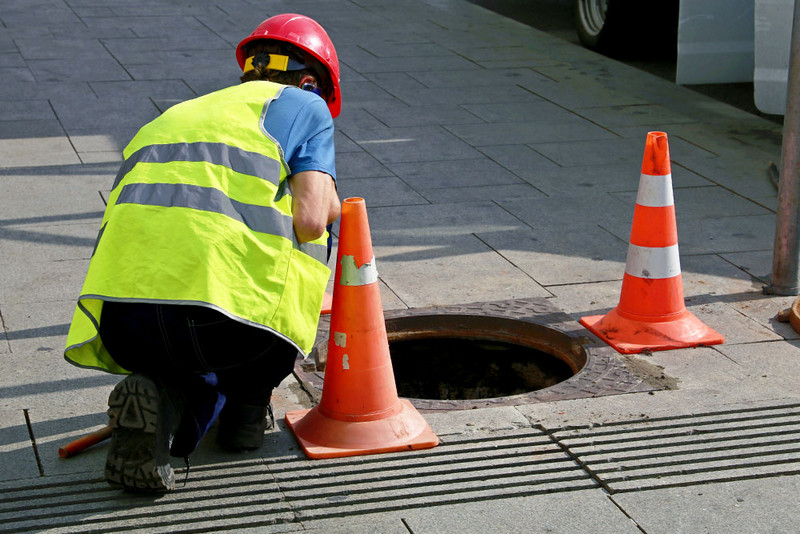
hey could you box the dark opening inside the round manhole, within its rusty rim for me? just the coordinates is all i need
[389,337,574,400]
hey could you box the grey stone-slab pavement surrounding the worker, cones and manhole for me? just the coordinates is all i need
[0,0,800,534]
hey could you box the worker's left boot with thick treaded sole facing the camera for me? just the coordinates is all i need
[105,374,179,492]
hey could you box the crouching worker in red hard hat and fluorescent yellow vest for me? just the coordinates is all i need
[65,14,341,491]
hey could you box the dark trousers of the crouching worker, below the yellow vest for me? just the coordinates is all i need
[100,302,297,456]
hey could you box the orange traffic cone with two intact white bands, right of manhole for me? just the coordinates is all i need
[580,132,725,354]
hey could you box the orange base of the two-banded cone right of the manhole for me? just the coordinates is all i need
[580,308,725,354]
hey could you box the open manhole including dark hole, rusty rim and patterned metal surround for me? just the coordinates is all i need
[295,298,670,411]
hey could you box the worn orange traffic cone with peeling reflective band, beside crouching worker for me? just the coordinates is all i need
[286,198,439,458]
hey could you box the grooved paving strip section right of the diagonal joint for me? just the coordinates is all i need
[551,404,800,493]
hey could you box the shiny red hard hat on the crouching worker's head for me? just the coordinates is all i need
[236,13,342,117]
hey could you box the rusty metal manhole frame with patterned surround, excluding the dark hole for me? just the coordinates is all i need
[294,298,670,412]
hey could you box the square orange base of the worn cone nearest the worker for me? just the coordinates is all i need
[286,399,439,458]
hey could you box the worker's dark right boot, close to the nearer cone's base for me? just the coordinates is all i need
[217,400,275,452]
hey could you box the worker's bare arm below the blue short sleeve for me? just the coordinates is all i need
[289,171,342,243]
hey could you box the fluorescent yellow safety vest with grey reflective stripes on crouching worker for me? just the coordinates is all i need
[65,81,330,373]
